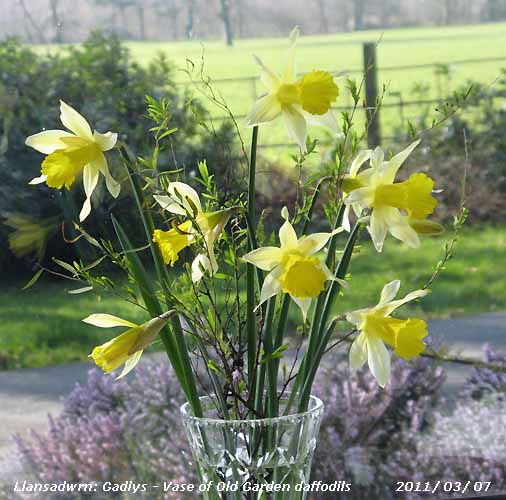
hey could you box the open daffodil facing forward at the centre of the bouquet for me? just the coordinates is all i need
[243,208,345,321]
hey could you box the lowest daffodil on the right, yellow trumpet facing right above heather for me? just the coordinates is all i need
[346,280,429,387]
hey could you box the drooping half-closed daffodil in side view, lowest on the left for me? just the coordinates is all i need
[83,311,174,378]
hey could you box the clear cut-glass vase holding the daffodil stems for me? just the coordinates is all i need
[181,396,323,500]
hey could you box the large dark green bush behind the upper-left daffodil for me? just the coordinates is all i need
[0,33,239,271]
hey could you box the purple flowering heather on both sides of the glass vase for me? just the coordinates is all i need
[10,347,506,500]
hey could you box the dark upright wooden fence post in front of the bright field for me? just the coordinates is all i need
[363,42,381,149]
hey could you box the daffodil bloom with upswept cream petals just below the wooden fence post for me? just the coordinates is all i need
[343,141,443,252]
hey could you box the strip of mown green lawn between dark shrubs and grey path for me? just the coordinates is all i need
[0,227,506,368]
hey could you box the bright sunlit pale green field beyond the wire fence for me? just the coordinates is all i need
[39,23,506,160]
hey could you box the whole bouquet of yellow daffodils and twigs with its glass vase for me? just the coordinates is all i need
[26,28,450,500]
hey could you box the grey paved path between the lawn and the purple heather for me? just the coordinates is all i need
[0,313,506,479]
